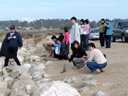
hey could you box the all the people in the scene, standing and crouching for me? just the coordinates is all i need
[0,17,112,74]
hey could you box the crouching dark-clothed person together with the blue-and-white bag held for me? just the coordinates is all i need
[55,38,68,60]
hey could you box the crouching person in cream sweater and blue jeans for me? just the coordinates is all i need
[86,43,107,74]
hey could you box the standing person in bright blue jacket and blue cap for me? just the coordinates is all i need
[105,19,112,48]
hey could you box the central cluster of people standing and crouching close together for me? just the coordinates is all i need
[51,17,108,74]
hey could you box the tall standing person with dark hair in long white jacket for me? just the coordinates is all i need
[69,17,80,49]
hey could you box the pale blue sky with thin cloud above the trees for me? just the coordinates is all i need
[0,0,128,21]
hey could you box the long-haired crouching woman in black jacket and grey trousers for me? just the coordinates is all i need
[69,41,87,68]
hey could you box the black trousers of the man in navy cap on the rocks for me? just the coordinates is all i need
[4,47,21,67]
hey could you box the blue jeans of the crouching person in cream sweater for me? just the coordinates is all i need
[87,62,107,72]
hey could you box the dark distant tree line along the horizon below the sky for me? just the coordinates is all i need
[0,19,127,30]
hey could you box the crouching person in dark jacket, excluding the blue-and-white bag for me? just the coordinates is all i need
[56,38,68,60]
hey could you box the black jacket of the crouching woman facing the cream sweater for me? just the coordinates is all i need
[69,47,87,62]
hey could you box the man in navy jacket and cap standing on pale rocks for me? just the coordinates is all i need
[4,25,23,67]
